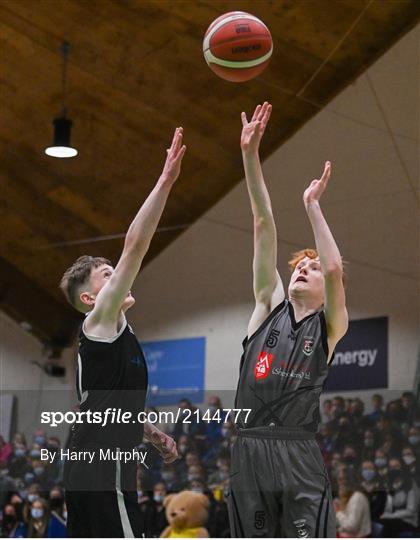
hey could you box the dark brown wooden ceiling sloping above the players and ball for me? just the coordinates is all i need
[0,0,420,349]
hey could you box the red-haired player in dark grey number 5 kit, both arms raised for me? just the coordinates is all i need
[229,102,348,538]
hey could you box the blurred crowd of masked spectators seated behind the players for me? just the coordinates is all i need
[0,392,420,538]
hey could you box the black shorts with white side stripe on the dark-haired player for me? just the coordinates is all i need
[64,446,143,538]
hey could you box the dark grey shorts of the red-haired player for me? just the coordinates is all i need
[229,427,336,538]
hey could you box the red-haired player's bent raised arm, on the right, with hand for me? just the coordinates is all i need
[303,161,348,356]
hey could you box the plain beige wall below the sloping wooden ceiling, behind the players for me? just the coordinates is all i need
[130,26,419,404]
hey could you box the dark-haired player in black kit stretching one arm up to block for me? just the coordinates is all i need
[60,128,186,538]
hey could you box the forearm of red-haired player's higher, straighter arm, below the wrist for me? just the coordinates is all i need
[242,152,274,220]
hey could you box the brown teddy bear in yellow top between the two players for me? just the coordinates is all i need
[160,491,209,538]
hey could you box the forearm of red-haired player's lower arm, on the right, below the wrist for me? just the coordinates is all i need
[306,201,343,275]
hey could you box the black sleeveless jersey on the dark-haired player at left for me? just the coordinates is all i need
[72,317,147,449]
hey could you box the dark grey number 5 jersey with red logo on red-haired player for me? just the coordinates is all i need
[235,300,328,432]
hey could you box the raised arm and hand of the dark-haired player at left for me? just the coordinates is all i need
[89,128,186,327]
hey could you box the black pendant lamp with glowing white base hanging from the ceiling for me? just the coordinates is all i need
[45,41,78,158]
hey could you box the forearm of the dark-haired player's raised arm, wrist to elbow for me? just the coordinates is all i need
[124,177,172,256]
